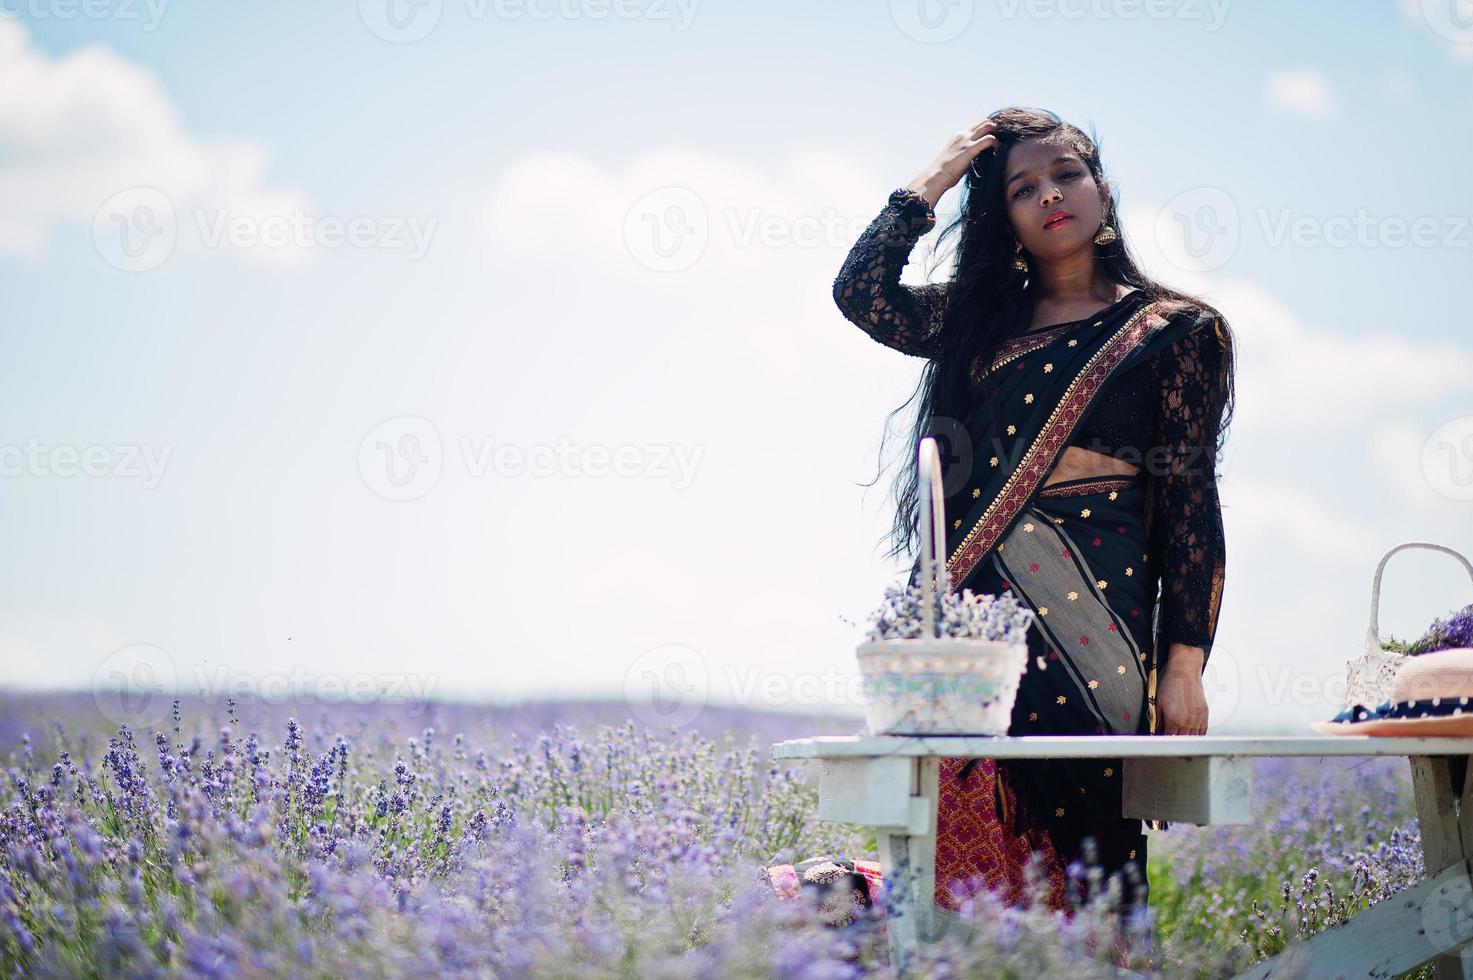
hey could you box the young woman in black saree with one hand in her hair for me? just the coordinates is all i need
[769,108,1234,943]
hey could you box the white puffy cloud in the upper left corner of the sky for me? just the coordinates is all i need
[0,18,306,264]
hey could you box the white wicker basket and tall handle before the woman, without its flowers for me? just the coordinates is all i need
[856,438,1028,735]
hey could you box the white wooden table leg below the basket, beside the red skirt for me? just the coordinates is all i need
[878,756,941,974]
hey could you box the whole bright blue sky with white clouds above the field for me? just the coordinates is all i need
[0,0,1473,731]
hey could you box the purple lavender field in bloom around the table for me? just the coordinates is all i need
[0,693,1421,979]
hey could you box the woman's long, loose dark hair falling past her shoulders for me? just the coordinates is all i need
[862,106,1236,560]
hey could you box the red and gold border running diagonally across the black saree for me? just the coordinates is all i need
[946,302,1167,588]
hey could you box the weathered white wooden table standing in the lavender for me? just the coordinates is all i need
[772,735,1473,980]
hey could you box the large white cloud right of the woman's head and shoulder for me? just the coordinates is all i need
[1122,203,1473,616]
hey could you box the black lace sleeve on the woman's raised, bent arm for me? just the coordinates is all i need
[834,190,947,357]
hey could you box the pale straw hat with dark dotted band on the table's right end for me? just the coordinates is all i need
[1314,647,1473,735]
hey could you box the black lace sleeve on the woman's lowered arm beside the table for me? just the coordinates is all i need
[1153,317,1228,663]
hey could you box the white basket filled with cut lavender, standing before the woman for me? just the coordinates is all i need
[856,438,1033,735]
